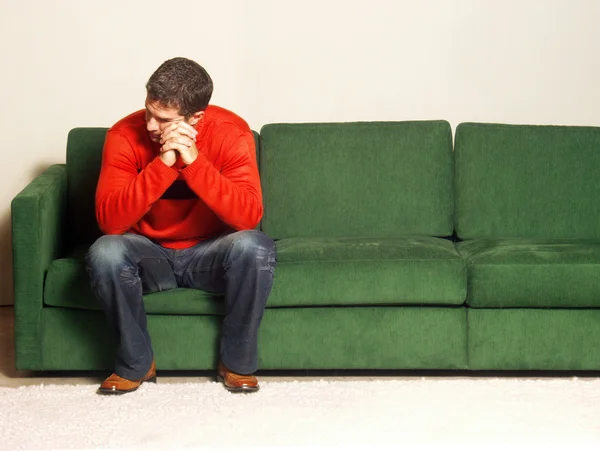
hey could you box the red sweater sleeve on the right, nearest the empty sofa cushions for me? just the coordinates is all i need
[181,132,263,230]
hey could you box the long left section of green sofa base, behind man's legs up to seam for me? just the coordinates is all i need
[36,307,467,370]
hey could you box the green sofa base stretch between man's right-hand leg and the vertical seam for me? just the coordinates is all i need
[259,306,467,369]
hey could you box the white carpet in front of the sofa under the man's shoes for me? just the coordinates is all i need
[0,378,600,450]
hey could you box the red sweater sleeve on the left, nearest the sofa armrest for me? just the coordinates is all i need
[96,131,178,234]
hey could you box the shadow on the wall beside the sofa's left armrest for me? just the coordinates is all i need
[0,163,58,305]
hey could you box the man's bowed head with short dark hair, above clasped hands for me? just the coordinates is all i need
[146,58,213,142]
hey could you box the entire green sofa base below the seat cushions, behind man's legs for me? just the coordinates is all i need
[29,306,600,371]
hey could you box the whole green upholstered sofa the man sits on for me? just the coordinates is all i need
[12,121,600,370]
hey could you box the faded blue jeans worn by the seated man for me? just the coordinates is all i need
[86,230,277,380]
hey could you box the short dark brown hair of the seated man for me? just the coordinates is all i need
[146,57,213,118]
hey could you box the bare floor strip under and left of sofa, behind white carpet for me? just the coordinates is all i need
[0,306,600,387]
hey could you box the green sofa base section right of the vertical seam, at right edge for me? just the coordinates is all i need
[468,309,600,371]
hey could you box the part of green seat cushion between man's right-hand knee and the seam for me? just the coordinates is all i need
[269,236,466,306]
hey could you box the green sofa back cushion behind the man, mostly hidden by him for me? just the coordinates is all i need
[67,127,258,248]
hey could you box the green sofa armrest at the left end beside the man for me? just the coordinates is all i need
[11,164,67,370]
